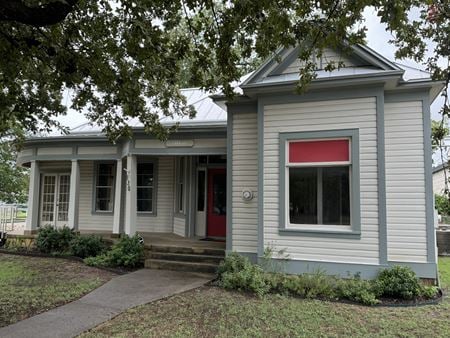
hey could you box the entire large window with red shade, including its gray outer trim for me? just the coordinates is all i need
[279,129,361,238]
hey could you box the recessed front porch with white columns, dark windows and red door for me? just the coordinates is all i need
[25,154,226,242]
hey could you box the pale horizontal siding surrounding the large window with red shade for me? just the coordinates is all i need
[263,97,379,264]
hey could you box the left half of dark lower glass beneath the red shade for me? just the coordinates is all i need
[289,168,317,224]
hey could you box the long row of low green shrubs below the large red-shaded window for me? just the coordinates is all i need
[219,253,437,305]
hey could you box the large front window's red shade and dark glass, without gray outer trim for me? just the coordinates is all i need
[286,138,351,225]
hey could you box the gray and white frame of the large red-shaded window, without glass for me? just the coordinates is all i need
[279,129,361,238]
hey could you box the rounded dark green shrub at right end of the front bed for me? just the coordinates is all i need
[375,266,422,299]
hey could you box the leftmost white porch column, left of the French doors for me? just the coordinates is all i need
[24,161,41,235]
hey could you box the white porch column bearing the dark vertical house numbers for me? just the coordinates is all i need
[125,155,137,236]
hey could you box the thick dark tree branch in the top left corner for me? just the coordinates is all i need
[0,0,78,27]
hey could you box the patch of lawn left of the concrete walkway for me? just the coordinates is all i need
[0,254,114,327]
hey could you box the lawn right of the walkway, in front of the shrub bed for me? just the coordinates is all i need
[82,258,450,338]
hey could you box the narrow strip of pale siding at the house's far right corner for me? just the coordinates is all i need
[384,101,427,262]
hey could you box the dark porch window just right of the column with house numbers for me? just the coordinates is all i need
[137,162,155,213]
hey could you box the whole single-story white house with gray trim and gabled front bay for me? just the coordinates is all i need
[18,46,442,279]
